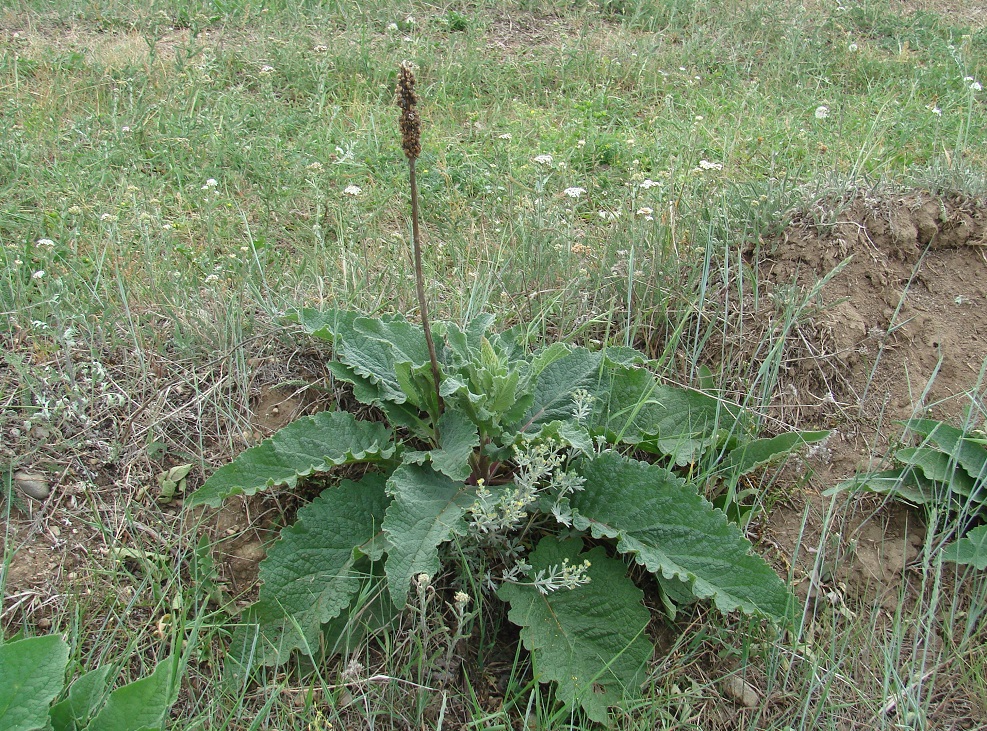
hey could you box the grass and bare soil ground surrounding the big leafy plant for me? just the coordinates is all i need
[0,0,987,731]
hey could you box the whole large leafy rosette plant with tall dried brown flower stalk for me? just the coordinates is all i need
[186,63,826,722]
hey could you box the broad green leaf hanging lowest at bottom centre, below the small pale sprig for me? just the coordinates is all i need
[497,536,654,723]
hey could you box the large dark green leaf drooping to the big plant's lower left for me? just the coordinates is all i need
[244,474,389,665]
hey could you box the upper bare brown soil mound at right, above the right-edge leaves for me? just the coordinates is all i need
[748,192,987,477]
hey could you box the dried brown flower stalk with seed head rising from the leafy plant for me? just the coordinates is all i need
[396,61,443,424]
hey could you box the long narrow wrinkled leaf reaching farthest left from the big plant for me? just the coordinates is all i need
[186,411,394,507]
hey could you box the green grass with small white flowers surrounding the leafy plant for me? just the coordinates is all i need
[0,0,987,729]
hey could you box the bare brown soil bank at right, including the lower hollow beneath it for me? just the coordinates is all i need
[731,192,987,611]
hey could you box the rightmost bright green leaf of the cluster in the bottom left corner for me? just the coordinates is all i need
[86,654,182,731]
